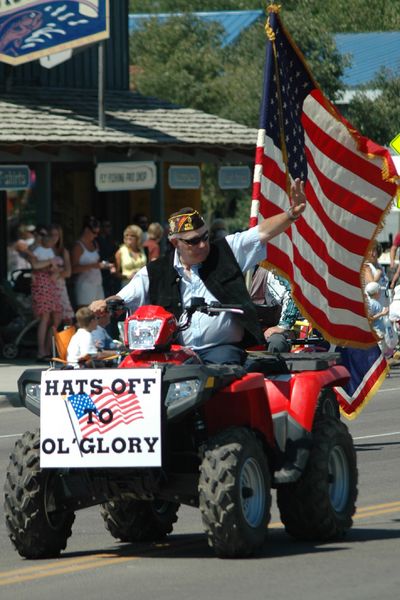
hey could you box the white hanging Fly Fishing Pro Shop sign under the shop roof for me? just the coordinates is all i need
[95,161,157,192]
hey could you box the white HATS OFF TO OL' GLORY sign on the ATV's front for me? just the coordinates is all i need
[40,369,161,468]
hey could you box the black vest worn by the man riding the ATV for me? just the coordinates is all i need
[147,239,264,346]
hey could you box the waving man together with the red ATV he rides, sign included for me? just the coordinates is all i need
[4,180,357,558]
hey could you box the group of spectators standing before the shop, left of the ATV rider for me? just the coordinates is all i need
[5,215,166,362]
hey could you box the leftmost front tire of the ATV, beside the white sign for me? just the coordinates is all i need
[4,430,75,558]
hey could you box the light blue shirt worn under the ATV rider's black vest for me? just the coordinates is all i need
[118,226,266,350]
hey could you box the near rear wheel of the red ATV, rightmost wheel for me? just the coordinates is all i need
[277,417,358,541]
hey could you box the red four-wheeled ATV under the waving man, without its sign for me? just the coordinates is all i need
[5,299,357,558]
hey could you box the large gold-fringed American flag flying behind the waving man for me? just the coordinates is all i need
[250,6,396,348]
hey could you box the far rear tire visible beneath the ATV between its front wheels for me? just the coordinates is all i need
[101,500,179,543]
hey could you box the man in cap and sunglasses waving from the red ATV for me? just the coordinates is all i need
[90,179,306,364]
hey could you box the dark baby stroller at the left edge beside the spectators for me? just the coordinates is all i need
[0,269,39,359]
